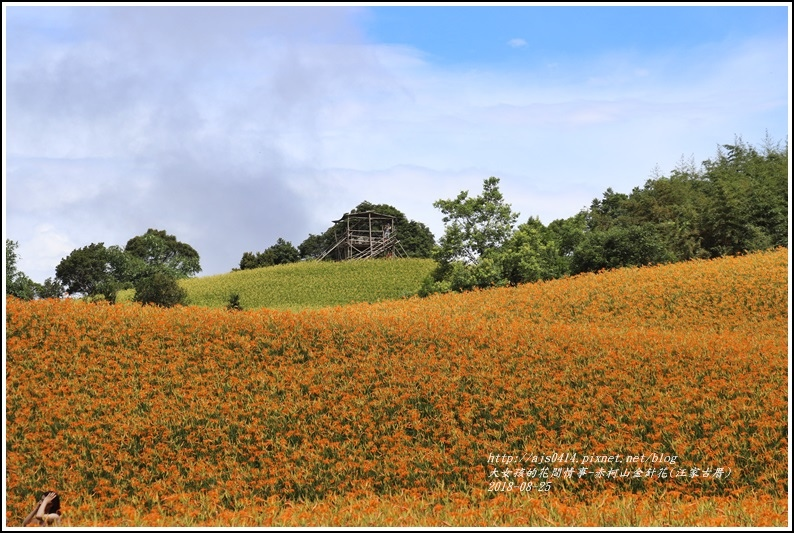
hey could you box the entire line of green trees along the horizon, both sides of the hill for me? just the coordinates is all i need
[6,134,788,305]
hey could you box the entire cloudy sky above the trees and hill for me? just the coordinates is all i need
[3,3,791,282]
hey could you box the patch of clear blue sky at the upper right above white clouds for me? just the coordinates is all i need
[365,5,788,64]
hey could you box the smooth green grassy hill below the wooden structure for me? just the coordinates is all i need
[118,259,435,310]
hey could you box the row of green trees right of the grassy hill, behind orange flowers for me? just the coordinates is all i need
[420,138,788,295]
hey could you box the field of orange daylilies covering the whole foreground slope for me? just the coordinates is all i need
[6,249,789,526]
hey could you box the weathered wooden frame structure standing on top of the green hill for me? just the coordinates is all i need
[319,211,407,261]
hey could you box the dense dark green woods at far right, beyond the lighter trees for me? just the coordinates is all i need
[571,135,788,273]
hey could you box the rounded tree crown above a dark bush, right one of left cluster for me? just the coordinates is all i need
[124,229,201,278]
